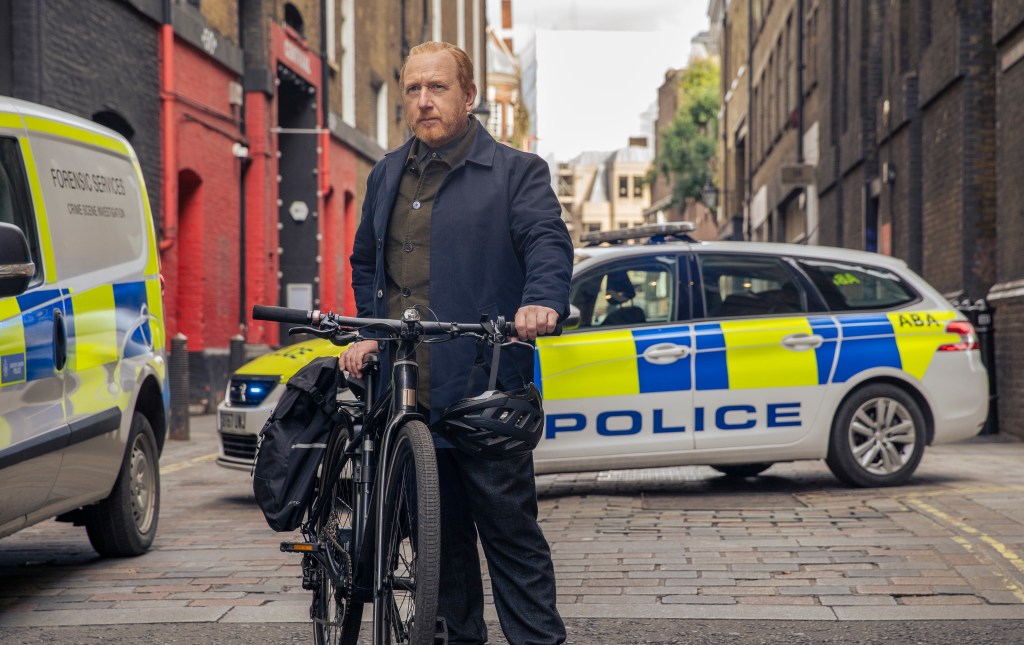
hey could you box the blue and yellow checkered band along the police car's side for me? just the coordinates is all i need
[534,310,957,400]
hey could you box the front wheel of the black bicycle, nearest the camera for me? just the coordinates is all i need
[374,421,441,645]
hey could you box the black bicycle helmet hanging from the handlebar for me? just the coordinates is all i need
[437,383,544,460]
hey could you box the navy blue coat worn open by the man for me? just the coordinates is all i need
[351,120,572,422]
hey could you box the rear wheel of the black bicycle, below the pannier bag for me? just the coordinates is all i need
[311,429,362,645]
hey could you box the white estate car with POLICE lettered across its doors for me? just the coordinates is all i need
[225,222,988,486]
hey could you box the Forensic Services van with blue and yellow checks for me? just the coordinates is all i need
[0,96,169,556]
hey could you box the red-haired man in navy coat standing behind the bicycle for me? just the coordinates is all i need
[342,42,572,645]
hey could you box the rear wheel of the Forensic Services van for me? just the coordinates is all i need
[85,412,160,557]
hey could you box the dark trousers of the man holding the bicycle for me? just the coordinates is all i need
[437,448,565,645]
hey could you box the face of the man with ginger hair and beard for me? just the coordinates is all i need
[402,51,476,147]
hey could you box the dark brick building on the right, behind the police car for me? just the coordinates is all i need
[709,0,1024,434]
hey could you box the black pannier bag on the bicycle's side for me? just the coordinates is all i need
[253,356,350,531]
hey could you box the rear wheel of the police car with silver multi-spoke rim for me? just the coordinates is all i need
[825,383,927,487]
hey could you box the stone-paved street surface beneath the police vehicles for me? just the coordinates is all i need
[0,416,1024,640]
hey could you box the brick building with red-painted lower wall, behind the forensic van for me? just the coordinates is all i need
[0,0,485,409]
